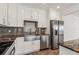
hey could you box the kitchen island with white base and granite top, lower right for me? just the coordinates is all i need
[59,39,79,55]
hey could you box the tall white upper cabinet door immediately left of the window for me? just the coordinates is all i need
[18,6,24,27]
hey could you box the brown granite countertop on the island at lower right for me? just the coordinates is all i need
[59,39,79,53]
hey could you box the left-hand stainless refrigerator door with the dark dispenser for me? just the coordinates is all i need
[51,20,58,49]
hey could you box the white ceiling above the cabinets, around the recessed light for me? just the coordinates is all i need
[19,3,79,11]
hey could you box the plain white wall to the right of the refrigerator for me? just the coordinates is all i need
[63,15,79,41]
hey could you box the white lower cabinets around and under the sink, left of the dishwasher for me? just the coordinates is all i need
[15,37,40,55]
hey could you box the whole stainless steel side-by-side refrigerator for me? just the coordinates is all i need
[50,20,64,49]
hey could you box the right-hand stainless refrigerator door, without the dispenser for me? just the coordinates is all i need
[59,21,64,44]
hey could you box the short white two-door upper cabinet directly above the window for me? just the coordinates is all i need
[24,7,39,21]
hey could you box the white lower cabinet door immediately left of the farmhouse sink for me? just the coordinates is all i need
[14,37,24,55]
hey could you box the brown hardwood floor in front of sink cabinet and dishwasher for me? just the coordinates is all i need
[32,49,59,55]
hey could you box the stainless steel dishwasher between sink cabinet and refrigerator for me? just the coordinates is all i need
[40,35,49,49]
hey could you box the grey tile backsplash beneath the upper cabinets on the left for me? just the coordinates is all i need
[0,27,23,35]
